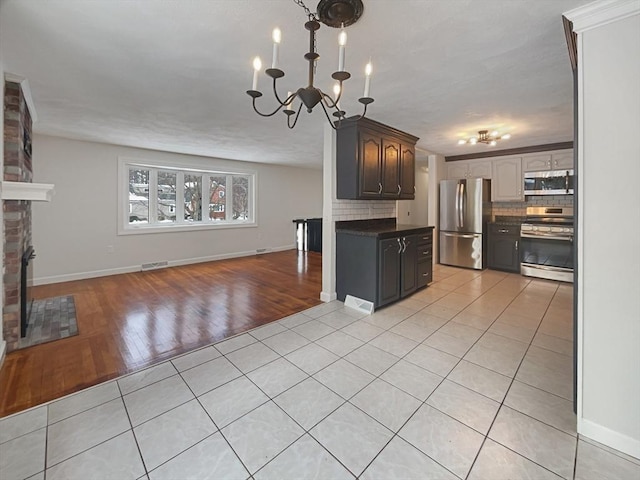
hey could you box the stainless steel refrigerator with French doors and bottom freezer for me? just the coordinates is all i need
[439,178,491,270]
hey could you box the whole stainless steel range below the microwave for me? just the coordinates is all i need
[520,207,574,282]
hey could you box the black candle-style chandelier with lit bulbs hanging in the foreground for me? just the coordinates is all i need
[247,0,373,129]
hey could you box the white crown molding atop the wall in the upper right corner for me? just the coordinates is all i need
[564,0,640,33]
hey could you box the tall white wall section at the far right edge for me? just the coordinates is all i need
[567,1,640,458]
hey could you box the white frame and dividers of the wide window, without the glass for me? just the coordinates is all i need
[118,157,258,235]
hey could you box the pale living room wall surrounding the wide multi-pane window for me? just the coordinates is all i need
[33,134,322,284]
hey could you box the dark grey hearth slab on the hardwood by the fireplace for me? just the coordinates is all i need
[18,295,78,348]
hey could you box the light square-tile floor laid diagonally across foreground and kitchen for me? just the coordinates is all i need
[0,266,640,480]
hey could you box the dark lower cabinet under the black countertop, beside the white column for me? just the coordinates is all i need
[336,228,433,308]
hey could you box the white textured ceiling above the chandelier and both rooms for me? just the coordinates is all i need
[0,0,590,168]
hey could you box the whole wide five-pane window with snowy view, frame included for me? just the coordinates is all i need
[119,160,255,234]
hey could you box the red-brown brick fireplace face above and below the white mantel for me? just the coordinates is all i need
[2,81,33,352]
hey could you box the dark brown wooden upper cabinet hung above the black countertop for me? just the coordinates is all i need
[336,118,418,200]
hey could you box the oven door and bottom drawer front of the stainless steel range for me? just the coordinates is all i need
[520,232,573,282]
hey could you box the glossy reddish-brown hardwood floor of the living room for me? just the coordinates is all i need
[0,250,322,417]
